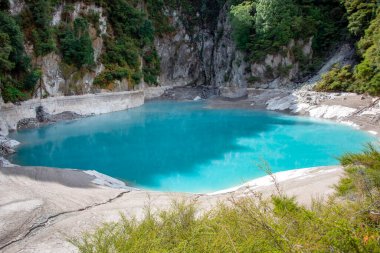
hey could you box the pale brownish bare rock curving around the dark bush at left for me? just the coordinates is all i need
[27,2,108,98]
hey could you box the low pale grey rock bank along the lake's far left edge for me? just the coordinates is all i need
[0,91,144,130]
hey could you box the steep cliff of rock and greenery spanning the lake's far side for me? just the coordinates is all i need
[0,0,374,102]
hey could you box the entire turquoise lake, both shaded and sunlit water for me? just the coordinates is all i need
[10,101,374,192]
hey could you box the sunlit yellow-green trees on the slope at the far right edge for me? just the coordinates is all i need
[316,0,380,96]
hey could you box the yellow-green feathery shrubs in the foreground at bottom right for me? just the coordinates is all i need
[72,146,380,253]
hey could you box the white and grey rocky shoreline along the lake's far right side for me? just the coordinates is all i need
[208,89,380,136]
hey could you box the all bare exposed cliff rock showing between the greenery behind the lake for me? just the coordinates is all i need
[10,0,313,98]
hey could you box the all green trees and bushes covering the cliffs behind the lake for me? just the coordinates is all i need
[0,0,380,101]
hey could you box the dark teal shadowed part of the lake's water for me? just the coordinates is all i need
[11,102,311,186]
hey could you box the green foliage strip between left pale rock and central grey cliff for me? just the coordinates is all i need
[96,0,159,87]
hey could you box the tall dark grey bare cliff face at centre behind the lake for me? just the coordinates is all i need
[155,5,248,97]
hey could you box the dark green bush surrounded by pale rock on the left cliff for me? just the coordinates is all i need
[59,18,94,68]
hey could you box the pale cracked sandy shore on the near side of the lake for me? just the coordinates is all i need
[0,166,343,253]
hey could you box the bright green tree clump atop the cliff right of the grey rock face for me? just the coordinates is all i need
[230,0,346,70]
